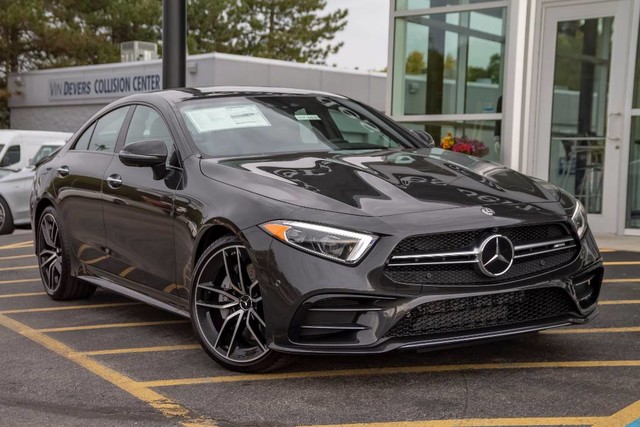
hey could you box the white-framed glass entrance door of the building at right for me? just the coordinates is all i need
[535,0,631,233]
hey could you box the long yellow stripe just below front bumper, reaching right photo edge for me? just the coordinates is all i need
[141,360,640,387]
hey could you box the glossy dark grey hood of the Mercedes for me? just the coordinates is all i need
[201,148,559,216]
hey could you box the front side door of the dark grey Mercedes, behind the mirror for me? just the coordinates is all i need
[103,105,177,293]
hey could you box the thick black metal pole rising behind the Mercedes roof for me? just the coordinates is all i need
[162,0,187,89]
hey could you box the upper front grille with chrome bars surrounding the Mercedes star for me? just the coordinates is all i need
[385,224,579,285]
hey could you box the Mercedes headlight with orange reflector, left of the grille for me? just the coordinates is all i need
[260,221,378,264]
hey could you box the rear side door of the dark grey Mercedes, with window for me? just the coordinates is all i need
[53,106,130,270]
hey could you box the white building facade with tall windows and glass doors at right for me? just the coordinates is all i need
[386,0,640,235]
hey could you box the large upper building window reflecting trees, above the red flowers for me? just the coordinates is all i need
[392,8,506,116]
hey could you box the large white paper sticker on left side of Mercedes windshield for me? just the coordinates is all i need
[186,105,271,132]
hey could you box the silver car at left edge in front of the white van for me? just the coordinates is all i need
[0,141,65,234]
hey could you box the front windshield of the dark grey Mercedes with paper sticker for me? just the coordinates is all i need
[180,95,410,157]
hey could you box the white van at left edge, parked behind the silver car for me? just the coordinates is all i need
[0,129,72,170]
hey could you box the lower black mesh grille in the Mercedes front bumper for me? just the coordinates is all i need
[385,288,575,338]
